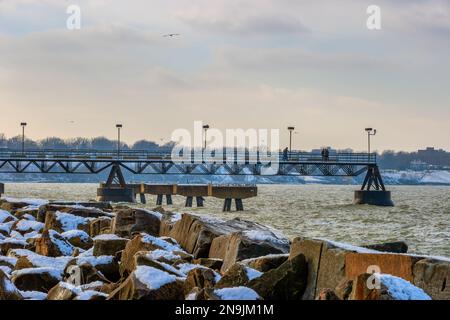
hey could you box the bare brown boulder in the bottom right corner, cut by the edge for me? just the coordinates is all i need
[413,259,450,300]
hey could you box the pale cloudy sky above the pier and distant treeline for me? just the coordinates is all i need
[0,0,450,151]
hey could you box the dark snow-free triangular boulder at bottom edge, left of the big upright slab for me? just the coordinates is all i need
[248,254,308,300]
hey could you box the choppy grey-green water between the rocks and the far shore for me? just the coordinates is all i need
[1,184,450,257]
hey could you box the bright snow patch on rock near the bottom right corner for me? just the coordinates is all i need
[375,274,431,300]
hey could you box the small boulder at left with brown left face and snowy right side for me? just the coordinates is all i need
[35,230,74,257]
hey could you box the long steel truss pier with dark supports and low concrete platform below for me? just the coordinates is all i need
[0,150,393,211]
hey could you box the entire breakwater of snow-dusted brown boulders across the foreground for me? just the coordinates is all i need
[0,199,450,300]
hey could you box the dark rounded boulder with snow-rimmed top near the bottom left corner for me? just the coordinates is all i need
[11,268,62,292]
